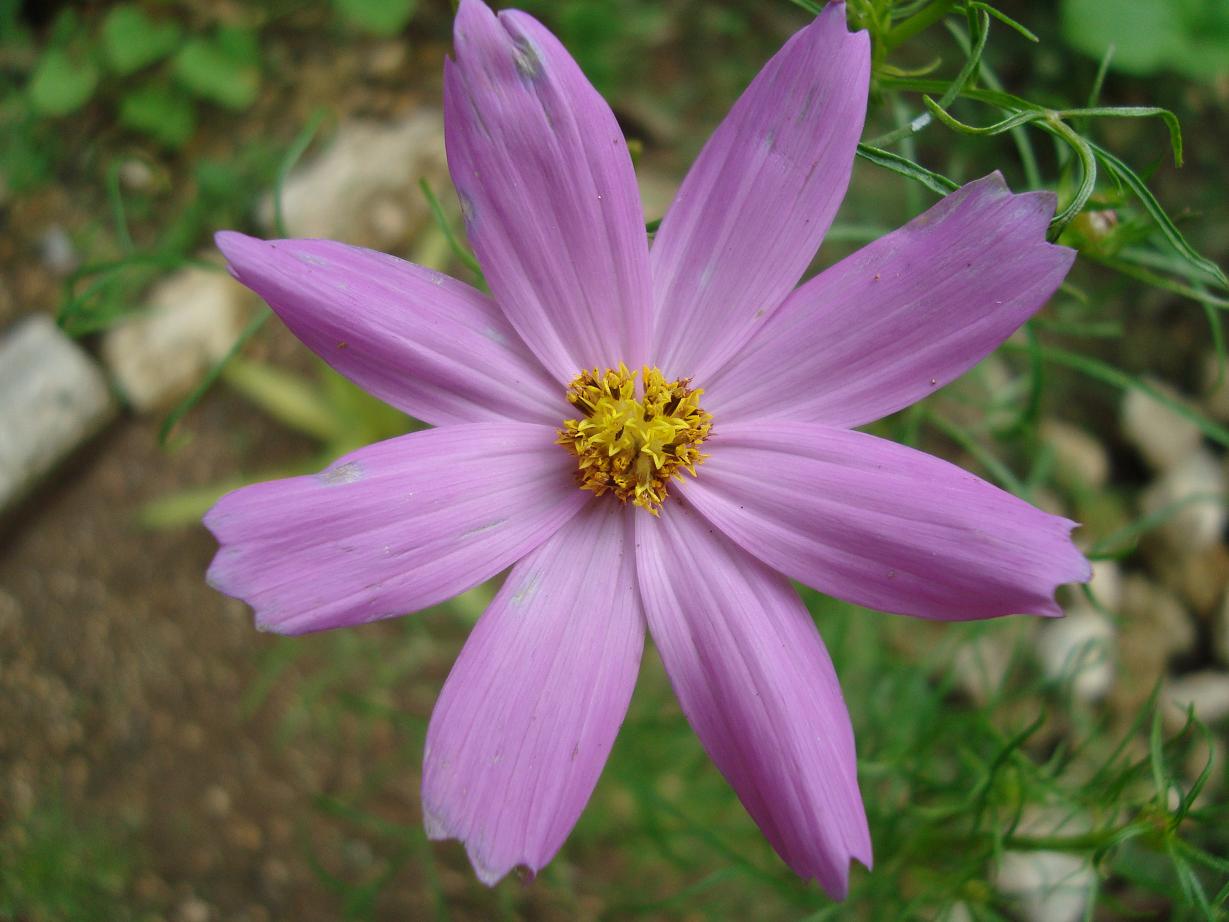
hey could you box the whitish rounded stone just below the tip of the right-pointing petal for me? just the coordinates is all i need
[1036,607,1117,702]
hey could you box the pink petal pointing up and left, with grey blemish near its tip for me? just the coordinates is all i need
[444,0,650,382]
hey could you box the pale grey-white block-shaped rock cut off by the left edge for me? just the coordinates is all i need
[0,313,116,511]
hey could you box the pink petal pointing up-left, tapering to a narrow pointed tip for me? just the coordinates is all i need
[218,231,568,425]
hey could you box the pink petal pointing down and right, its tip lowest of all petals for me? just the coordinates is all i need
[635,502,871,899]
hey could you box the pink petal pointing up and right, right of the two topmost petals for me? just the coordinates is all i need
[651,4,870,381]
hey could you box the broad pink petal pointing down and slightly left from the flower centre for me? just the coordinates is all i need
[423,502,644,884]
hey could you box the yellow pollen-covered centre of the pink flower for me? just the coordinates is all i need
[558,363,713,515]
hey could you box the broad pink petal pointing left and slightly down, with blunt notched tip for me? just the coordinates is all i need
[205,423,586,634]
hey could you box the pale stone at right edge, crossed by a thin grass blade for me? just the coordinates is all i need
[1142,447,1229,553]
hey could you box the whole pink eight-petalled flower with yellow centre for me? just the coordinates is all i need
[205,0,1089,897]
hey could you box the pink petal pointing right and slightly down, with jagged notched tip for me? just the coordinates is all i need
[677,420,1091,621]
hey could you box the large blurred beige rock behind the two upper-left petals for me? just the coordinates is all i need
[261,109,451,250]
